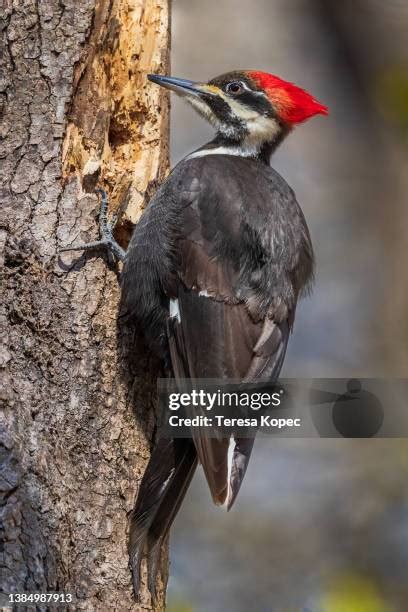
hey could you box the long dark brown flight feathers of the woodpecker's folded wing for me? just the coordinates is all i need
[169,288,289,507]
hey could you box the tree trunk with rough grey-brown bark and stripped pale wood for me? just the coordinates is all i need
[0,0,169,610]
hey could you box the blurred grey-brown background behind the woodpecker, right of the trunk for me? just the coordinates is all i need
[168,0,408,612]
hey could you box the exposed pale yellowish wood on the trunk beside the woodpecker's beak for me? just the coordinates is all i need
[63,0,169,239]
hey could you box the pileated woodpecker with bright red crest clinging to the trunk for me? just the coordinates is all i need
[61,71,328,596]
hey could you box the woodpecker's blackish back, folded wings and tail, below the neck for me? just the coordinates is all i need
[121,155,313,598]
